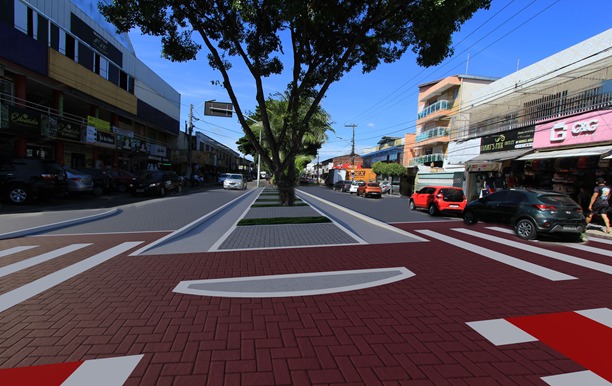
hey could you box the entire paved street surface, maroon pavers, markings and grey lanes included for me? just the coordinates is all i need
[0,188,612,385]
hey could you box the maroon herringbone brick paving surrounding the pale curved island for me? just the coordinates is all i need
[0,223,612,385]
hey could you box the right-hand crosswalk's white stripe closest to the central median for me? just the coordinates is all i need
[417,229,577,281]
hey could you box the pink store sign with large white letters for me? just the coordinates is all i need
[533,111,612,149]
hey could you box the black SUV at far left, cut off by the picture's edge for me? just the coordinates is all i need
[0,158,68,204]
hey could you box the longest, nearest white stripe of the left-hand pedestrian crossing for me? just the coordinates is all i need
[0,241,143,312]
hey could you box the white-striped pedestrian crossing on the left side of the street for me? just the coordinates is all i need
[0,241,143,312]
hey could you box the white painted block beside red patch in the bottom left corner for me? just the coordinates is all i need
[62,354,144,386]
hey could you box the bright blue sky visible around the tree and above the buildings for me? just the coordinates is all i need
[129,0,612,161]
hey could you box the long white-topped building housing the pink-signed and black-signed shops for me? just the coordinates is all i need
[451,29,612,199]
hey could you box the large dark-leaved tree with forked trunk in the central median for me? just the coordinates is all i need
[100,0,491,204]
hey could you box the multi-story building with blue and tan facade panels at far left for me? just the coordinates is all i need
[0,0,180,170]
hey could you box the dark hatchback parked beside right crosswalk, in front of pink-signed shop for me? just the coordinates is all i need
[463,189,586,240]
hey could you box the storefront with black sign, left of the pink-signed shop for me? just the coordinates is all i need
[464,126,535,200]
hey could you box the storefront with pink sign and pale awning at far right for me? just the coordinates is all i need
[518,111,612,205]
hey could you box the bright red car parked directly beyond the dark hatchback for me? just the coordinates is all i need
[408,186,467,216]
